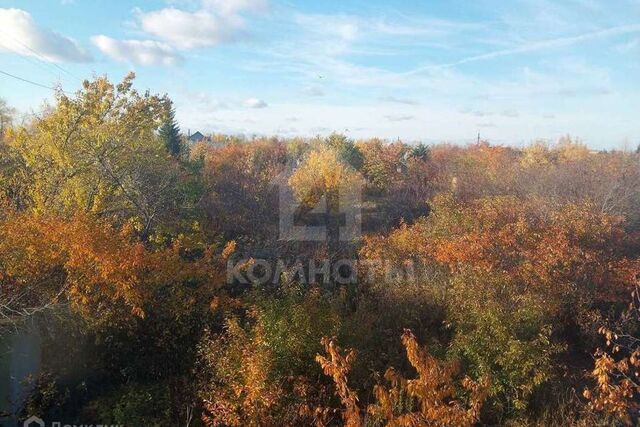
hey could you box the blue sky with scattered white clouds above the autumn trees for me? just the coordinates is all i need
[0,0,640,148]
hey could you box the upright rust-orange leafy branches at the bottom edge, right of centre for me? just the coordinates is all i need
[316,330,489,427]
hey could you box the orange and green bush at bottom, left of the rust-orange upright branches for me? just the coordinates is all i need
[198,284,340,426]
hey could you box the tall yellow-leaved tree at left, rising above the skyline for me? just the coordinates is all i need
[9,74,183,236]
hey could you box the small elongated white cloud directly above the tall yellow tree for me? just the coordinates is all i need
[91,35,182,65]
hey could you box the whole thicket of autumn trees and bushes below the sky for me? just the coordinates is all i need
[0,77,640,426]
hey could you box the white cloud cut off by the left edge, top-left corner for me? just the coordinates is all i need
[0,9,92,62]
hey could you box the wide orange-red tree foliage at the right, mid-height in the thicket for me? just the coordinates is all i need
[361,195,637,308]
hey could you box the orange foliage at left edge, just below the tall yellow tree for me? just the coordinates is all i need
[0,210,230,324]
